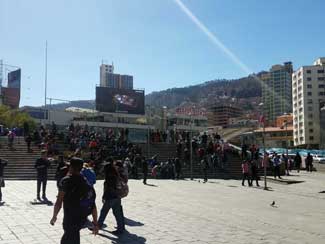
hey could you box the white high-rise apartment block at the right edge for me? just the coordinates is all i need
[292,58,325,147]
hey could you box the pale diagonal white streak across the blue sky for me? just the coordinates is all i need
[174,0,253,75]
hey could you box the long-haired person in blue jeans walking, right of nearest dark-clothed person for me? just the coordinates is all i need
[98,163,125,235]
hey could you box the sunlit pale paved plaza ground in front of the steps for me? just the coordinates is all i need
[0,172,325,244]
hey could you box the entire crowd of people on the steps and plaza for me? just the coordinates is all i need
[0,123,313,244]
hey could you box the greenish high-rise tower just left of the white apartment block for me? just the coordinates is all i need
[260,62,293,124]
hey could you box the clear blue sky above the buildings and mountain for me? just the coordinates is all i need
[0,0,325,105]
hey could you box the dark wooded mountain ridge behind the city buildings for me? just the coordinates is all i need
[31,75,262,110]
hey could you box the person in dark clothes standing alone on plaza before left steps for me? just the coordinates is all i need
[34,150,50,201]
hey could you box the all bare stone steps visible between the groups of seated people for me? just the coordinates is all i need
[0,137,241,180]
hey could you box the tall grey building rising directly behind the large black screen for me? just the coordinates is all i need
[100,64,133,89]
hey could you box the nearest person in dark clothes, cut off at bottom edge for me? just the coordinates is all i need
[50,157,98,244]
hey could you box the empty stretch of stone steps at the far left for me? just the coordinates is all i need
[0,137,56,180]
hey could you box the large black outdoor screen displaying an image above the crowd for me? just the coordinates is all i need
[96,87,144,114]
